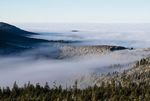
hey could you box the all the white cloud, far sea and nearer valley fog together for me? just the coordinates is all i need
[0,24,150,86]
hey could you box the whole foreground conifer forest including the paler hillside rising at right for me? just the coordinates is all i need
[0,58,150,101]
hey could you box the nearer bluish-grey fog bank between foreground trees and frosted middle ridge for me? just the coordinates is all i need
[0,47,149,87]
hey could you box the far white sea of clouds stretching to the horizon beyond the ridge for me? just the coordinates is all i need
[18,23,150,48]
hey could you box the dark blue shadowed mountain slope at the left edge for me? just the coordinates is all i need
[0,22,48,54]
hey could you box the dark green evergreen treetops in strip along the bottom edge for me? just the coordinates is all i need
[0,80,150,101]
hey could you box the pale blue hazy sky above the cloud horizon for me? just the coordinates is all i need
[0,0,150,23]
